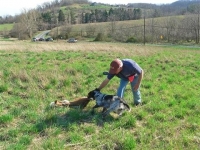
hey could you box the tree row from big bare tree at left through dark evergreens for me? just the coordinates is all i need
[7,5,142,39]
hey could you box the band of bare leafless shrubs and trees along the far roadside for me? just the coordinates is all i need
[54,16,200,44]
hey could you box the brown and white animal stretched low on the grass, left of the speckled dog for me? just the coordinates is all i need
[50,97,90,109]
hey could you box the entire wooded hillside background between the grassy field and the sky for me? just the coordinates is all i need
[1,0,199,43]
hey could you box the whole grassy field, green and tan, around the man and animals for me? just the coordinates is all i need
[0,41,200,150]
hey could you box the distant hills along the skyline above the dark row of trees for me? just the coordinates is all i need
[0,0,200,24]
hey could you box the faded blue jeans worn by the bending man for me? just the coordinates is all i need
[117,75,142,105]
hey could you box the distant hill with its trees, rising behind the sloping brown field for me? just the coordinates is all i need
[0,0,200,41]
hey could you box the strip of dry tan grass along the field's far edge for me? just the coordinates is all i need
[0,41,161,56]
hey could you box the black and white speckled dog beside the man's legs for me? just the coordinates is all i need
[87,89,131,118]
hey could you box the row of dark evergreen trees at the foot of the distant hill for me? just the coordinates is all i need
[40,8,142,25]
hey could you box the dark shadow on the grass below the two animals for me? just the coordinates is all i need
[35,108,115,133]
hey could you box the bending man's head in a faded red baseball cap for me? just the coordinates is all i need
[109,59,123,74]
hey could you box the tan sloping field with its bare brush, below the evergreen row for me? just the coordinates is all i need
[47,14,200,44]
